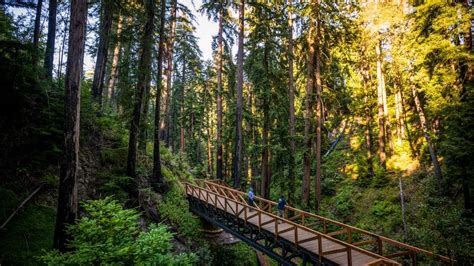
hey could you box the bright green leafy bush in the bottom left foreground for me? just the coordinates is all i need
[41,198,195,265]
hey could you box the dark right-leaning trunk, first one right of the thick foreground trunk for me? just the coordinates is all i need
[92,0,113,107]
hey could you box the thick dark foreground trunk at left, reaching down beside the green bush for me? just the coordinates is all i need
[53,0,87,252]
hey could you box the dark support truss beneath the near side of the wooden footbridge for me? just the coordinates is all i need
[188,196,336,265]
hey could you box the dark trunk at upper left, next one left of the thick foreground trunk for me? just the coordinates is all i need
[44,0,58,79]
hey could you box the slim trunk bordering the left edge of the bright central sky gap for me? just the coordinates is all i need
[160,0,178,142]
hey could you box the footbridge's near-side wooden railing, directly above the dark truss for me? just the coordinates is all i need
[183,182,400,265]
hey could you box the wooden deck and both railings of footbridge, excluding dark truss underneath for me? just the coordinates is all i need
[185,180,453,265]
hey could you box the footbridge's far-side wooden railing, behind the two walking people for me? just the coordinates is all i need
[199,180,455,263]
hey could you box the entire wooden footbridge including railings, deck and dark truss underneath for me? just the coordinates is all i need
[184,180,454,265]
